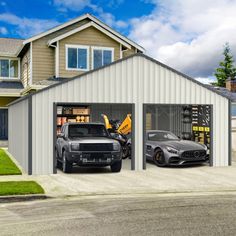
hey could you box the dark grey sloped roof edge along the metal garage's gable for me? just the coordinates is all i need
[8,53,232,106]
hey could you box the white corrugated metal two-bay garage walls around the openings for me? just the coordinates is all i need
[9,54,231,174]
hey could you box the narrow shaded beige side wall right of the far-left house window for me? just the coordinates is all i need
[21,48,31,88]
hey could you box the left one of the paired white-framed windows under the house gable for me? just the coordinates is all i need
[66,45,89,71]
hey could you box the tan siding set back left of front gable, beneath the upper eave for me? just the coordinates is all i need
[32,19,89,83]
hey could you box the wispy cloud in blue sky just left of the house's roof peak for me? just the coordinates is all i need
[0,13,59,38]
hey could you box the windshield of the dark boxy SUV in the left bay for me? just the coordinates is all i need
[69,124,108,138]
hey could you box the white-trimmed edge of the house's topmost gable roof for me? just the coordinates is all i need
[23,13,145,52]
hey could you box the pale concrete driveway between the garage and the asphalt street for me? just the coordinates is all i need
[0,161,236,197]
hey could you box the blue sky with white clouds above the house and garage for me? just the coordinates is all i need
[0,0,236,82]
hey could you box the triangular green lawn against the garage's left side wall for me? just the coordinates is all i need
[0,149,21,175]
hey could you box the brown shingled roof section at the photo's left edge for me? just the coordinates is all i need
[0,38,24,57]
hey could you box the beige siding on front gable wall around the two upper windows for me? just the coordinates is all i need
[59,26,120,78]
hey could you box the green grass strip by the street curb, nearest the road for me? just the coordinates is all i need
[0,181,44,196]
